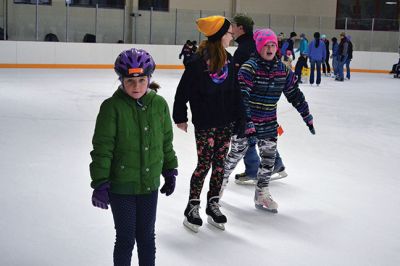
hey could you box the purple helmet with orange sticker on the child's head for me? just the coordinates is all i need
[114,48,156,78]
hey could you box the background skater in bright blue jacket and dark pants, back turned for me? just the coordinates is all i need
[308,32,326,86]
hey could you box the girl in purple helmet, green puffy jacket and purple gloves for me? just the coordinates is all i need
[90,49,178,266]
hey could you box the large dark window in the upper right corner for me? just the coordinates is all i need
[336,0,400,31]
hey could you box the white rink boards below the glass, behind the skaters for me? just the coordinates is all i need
[0,41,399,71]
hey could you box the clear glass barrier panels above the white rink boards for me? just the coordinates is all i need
[0,0,400,52]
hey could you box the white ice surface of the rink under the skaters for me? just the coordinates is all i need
[0,69,400,266]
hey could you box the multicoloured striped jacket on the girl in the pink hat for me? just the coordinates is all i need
[238,54,310,139]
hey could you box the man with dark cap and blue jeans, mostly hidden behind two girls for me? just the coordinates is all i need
[224,14,285,188]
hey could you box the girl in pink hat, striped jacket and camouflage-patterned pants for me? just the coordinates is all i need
[225,29,315,212]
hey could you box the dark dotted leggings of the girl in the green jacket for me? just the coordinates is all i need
[110,191,158,266]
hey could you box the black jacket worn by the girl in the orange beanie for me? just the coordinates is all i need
[172,53,243,130]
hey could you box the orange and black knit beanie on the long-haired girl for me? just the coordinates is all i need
[196,16,231,41]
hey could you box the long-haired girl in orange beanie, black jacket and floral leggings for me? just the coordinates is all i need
[173,16,243,232]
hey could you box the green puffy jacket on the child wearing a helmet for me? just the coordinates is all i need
[90,89,178,195]
